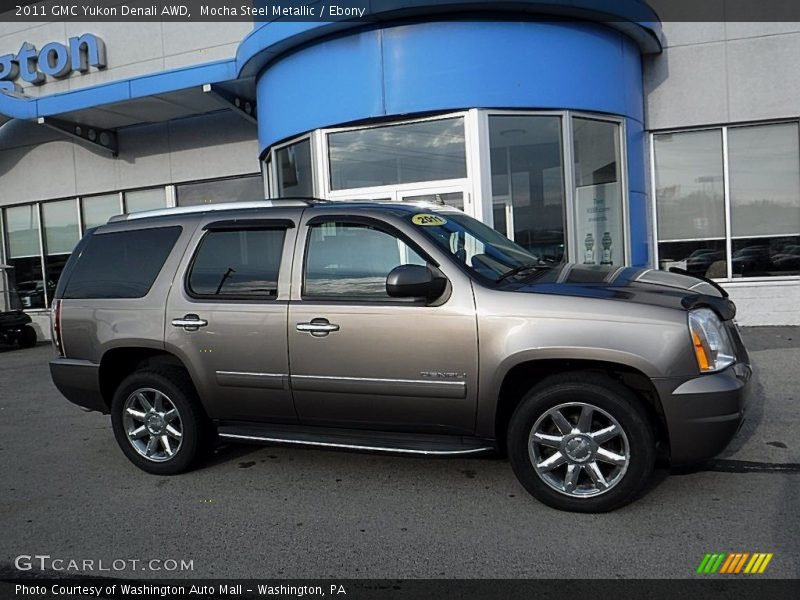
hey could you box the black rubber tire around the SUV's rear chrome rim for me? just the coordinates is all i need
[111,368,213,475]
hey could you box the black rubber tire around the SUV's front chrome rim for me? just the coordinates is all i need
[508,372,656,513]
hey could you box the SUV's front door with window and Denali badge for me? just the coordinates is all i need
[289,209,478,433]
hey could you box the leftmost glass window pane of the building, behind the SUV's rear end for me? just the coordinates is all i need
[5,204,46,309]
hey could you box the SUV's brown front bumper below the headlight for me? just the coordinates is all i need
[653,363,753,465]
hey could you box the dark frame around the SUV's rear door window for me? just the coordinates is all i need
[183,223,295,304]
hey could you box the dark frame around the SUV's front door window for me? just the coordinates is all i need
[300,215,438,306]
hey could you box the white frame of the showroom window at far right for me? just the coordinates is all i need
[647,119,800,287]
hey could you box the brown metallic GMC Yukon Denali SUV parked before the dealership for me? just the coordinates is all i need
[50,199,751,512]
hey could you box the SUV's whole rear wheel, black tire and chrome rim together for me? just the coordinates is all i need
[111,369,211,475]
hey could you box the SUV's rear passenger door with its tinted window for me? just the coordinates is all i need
[165,217,297,423]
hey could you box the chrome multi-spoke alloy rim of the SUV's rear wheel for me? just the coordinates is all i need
[122,388,183,462]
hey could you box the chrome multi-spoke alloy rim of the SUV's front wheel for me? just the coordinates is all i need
[528,402,631,498]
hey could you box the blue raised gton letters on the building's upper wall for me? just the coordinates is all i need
[0,33,106,92]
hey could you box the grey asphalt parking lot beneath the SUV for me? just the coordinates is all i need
[0,328,800,579]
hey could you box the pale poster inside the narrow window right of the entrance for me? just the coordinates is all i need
[576,183,625,265]
